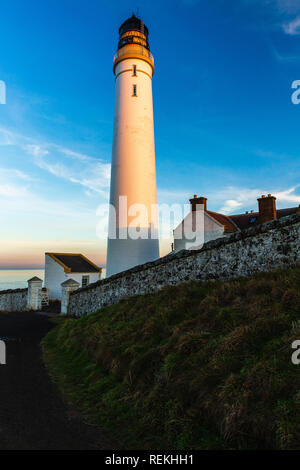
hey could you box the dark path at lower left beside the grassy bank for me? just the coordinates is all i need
[0,313,113,450]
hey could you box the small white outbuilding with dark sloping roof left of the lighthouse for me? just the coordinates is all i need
[45,253,102,300]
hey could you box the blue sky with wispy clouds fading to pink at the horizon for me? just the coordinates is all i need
[0,0,300,267]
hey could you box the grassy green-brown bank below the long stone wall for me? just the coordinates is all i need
[42,268,300,450]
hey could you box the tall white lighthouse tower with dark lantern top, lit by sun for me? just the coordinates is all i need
[107,15,159,276]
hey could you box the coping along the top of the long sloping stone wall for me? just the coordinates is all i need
[70,214,300,295]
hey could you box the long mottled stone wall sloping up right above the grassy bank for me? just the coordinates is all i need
[68,214,300,316]
